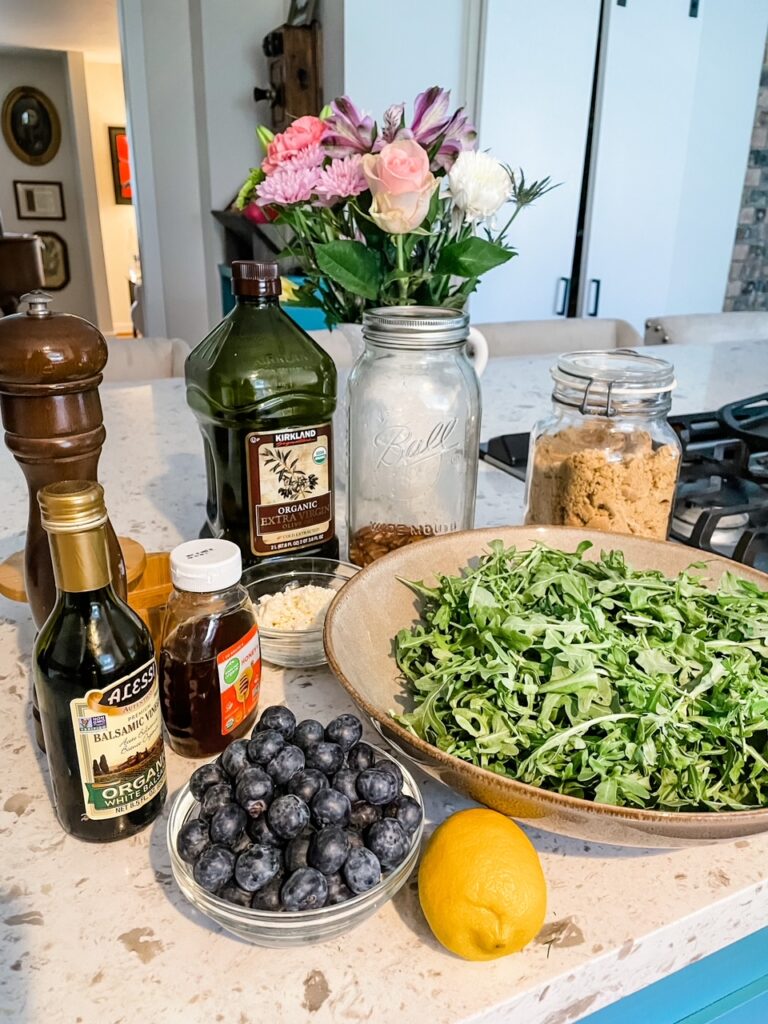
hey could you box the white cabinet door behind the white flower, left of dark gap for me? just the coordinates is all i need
[471,0,600,323]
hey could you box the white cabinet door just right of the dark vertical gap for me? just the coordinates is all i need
[579,0,701,333]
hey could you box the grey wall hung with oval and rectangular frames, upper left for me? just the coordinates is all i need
[0,50,97,322]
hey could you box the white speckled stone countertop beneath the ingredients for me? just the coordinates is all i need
[0,344,768,1024]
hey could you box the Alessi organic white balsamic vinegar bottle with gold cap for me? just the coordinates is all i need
[33,480,166,843]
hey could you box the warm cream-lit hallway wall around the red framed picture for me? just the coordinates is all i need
[85,60,138,333]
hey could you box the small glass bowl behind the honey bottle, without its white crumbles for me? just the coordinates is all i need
[241,557,359,669]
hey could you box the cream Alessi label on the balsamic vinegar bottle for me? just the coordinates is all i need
[70,658,165,820]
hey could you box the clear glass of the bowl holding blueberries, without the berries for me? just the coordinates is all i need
[166,744,424,946]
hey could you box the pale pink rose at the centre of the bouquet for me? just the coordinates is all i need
[362,139,437,234]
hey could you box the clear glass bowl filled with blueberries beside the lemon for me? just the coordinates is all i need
[168,705,424,946]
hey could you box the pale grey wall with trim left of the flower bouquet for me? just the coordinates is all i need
[119,0,286,344]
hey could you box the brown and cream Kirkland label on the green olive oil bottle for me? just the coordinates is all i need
[246,423,334,555]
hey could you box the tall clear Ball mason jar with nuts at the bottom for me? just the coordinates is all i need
[347,306,480,565]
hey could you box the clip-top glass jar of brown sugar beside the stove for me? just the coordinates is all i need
[525,349,681,541]
